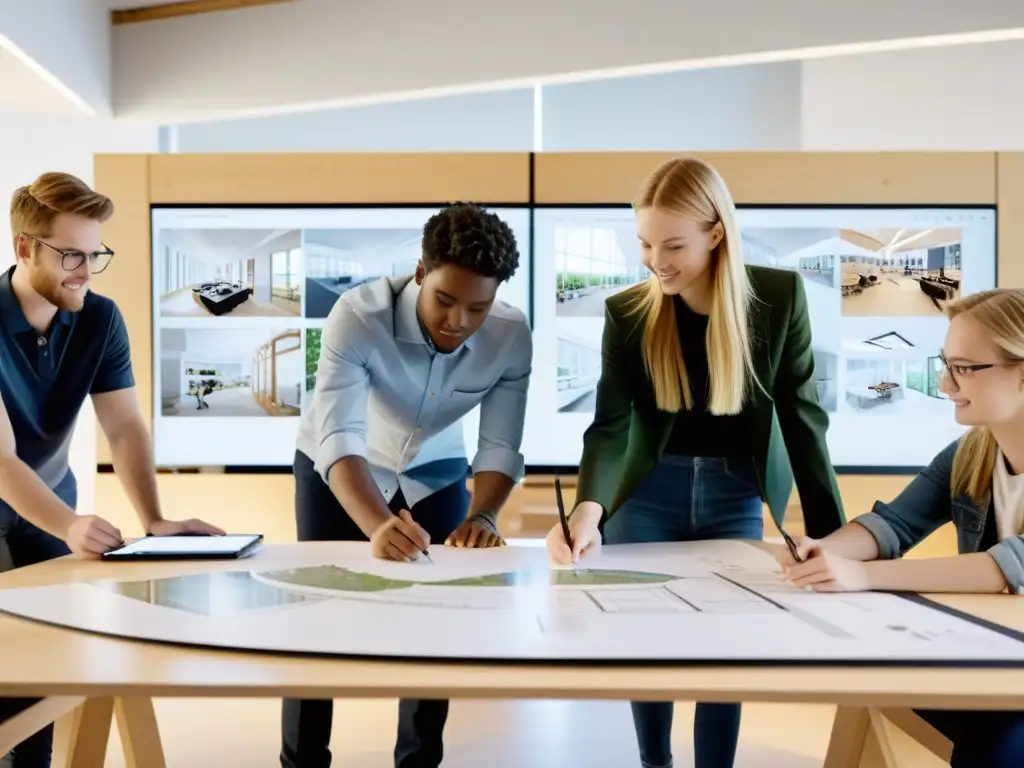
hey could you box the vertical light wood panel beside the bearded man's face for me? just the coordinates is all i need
[93,155,153,460]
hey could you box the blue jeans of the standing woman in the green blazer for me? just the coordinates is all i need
[604,456,764,768]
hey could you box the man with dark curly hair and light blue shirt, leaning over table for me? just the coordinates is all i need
[281,204,534,768]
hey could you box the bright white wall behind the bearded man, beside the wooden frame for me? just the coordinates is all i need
[0,109,157,514]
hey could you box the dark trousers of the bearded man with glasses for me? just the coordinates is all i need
[0,471,78,768]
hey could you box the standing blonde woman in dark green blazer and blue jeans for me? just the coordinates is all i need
[548,158,844,768]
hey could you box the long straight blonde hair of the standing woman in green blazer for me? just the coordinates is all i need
[631,157,757,415]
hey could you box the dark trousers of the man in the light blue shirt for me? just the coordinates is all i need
[281,453,469,768]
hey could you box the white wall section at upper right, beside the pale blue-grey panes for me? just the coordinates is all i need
[802,41,1024,152]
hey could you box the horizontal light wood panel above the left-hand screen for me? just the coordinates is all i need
[150,153,529,203]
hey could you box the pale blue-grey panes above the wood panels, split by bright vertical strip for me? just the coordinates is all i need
[176,62,801,153]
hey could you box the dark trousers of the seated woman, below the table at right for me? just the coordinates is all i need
[916,710,1024,768]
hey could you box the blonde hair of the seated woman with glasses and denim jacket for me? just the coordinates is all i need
[946,288,1024,505]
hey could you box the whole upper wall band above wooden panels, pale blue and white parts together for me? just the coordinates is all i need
[177,41,1024,152]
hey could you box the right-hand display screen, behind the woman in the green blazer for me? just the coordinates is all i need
[527,207,996,471]
